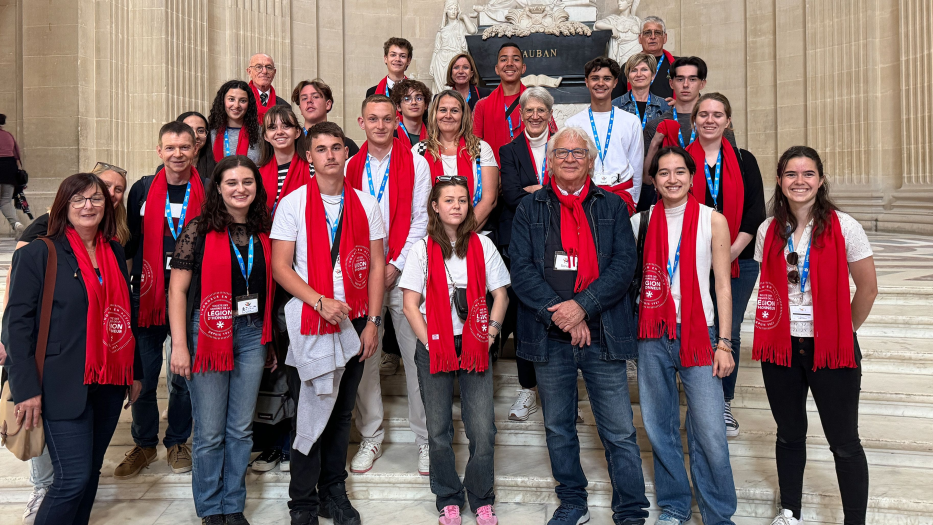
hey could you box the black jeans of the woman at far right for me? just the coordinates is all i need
[761,337,868,525]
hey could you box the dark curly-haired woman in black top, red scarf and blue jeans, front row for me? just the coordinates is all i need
[169,156,275,525]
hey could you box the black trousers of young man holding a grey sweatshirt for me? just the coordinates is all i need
[286,317,366,514]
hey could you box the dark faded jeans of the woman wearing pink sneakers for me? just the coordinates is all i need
[415,337,496,512]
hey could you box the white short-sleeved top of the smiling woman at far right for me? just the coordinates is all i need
[755,211,872,337]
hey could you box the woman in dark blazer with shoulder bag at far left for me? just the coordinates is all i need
[3,173,142,525]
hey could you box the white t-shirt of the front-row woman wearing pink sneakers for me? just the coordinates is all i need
[398,235,512,335]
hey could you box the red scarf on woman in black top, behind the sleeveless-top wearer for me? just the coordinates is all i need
[687,137,745,278]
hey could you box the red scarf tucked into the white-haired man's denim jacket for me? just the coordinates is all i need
[551,184,599,293]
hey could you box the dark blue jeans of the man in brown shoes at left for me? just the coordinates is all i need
[130,285,191,448]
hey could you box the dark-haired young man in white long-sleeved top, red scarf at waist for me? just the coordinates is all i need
[564,57,645,215]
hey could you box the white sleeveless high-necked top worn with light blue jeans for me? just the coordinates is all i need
[632,204,713,326]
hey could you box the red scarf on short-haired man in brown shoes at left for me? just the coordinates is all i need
[138,166,204,328]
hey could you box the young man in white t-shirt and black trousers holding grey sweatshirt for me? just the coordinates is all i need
[270,122,385,525]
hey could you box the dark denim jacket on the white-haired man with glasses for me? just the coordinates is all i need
[509,182,638,362]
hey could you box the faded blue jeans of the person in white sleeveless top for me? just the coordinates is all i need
[638,325,737,525]
